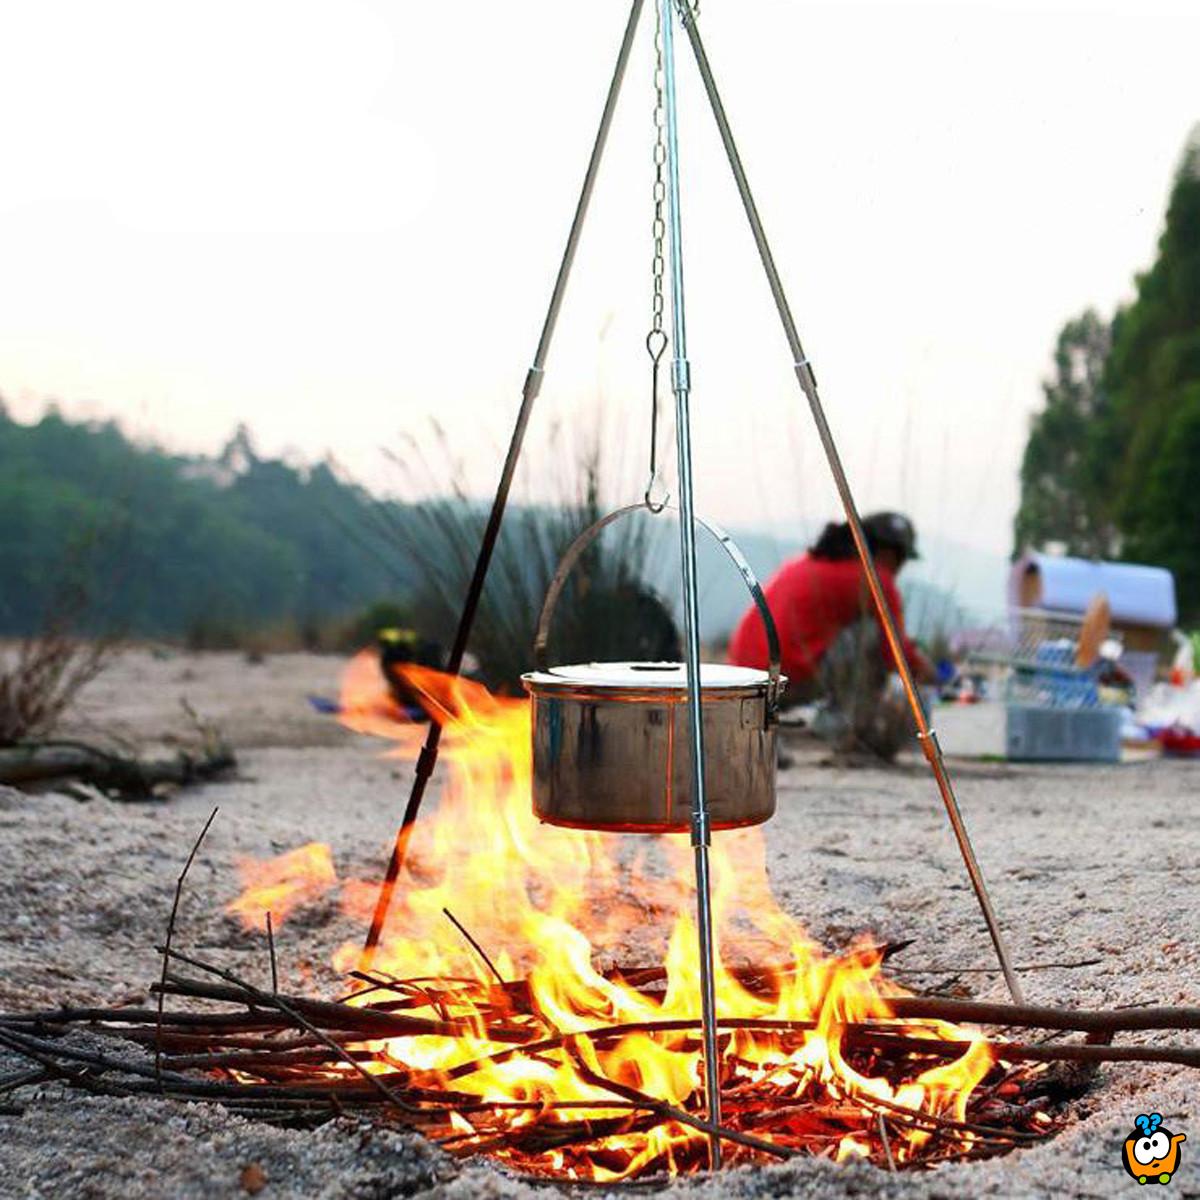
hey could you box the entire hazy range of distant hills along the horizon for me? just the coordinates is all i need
[0,408,1004,654]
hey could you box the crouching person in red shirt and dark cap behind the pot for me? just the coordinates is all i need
[728,512,936,700]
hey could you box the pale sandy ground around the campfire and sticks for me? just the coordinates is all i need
[0,653,1200,1200]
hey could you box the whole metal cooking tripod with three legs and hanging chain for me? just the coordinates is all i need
[362,0,1022,1169]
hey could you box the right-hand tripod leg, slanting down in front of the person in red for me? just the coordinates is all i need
[680,5,1024,1004]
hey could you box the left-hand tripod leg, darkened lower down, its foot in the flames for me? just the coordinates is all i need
[359,0,644,971]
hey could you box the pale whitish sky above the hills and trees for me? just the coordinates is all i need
[0,0,1200,551]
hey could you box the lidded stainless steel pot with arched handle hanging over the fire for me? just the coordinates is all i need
[522,504,786,833]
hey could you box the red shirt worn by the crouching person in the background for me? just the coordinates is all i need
[728,554,917,683]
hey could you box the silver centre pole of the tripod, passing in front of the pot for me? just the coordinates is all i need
[659,0,721,1171]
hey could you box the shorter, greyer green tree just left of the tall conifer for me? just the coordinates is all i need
[1013,308,1116,558]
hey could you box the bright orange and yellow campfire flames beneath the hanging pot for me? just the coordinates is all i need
[230,652,992,1182]
